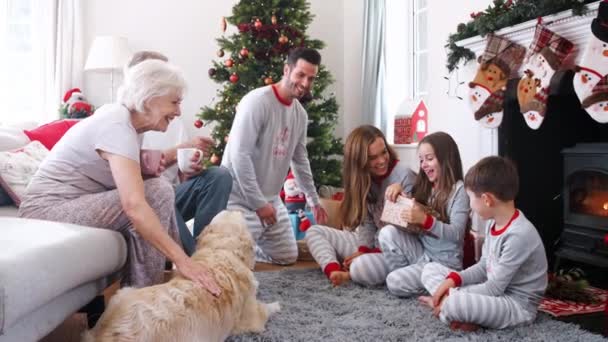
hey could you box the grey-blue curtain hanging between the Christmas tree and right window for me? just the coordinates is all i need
[362,0,387,132]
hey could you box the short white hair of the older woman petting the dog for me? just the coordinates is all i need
[118,59,186,113]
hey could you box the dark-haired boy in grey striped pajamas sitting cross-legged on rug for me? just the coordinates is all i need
[420,157,547,331]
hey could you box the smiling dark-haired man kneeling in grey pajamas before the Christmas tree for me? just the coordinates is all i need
[222,48,327,265]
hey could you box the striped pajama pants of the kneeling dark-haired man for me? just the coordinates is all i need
[227,197,298,265]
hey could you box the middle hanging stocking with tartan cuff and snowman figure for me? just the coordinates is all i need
[517,24,574,129]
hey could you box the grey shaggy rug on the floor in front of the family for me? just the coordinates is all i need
[228,269,607,342]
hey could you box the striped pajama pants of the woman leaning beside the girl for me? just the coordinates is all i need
[306,225,388,286]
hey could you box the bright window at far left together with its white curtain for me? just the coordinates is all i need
[0,0,83,123]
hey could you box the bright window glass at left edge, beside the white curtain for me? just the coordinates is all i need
[0,0,38,123]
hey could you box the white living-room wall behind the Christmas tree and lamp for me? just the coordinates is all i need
[84,0,496,170]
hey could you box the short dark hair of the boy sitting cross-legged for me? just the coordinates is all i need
[464,156,519,202]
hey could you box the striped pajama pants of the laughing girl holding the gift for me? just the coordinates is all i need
[378,225,430,297]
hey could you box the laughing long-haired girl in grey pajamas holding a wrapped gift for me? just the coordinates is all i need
[378,132,469,297]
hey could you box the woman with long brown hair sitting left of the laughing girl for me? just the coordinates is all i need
[306,125,415,286]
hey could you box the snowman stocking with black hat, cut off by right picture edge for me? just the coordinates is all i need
[572,1,608,123]
